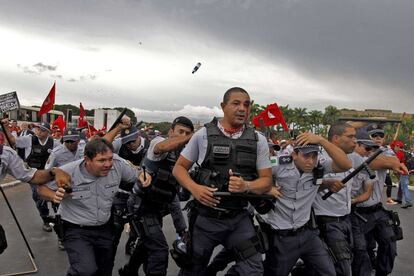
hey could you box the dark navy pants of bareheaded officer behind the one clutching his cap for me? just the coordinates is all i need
[317,217,353,276]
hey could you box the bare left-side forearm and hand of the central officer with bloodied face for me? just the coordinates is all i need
[173,155,220,207]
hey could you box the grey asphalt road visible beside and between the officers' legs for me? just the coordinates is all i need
[0,184,414,276]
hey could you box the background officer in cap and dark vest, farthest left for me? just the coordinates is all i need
[3,119,60,232]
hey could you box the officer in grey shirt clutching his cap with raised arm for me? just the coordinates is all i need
[264,133,352,276]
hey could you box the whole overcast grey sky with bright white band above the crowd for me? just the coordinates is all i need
[0,0,414,121]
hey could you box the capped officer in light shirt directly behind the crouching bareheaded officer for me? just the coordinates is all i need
[45,129,83,169]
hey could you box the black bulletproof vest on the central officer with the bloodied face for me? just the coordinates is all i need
[198,120,258,209]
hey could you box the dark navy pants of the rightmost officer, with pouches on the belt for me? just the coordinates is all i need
[351,210,397,276]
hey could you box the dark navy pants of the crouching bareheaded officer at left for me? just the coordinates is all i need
[63,224,114,276]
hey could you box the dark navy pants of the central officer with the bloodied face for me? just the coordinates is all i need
[179,211,263,276]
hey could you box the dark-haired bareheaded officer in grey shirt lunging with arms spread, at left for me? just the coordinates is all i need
[39,138,151,276]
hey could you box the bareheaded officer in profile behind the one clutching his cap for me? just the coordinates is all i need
[312,123,372,276]
